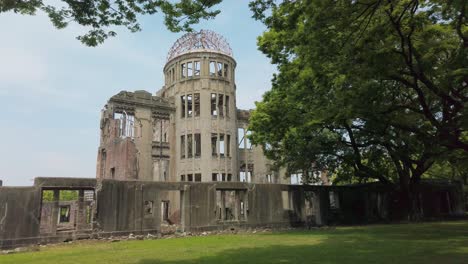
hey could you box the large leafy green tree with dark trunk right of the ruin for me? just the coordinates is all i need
[250,0,468,217]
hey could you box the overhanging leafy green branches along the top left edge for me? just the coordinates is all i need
[0,0,222,46]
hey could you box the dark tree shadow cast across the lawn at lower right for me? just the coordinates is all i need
[138,223,468,264]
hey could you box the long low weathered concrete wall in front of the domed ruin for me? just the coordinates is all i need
[0,178,465,248]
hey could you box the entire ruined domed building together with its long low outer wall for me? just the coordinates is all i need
[0,30,465,249]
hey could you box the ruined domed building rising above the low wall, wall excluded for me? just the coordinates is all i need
[96,30,285,183]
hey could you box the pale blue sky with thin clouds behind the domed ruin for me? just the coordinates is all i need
[0,0,275,186]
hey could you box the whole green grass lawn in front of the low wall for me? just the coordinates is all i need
[0,221,468,264]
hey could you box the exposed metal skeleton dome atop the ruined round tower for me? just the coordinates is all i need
[167,30,232,61]
